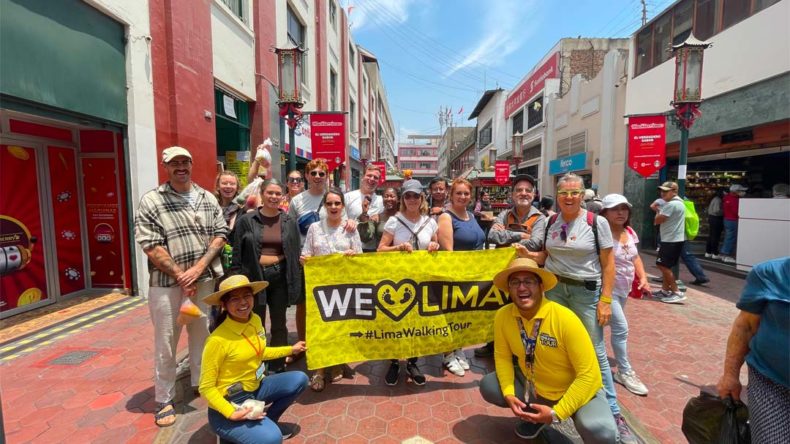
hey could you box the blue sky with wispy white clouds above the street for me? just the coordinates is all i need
[350,0,674,145]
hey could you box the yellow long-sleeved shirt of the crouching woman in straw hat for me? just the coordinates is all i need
[199,313,291,418]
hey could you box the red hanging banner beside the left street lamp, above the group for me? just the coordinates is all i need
[310,113,346,172]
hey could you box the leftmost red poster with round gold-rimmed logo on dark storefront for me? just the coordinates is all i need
[0,145,49,311]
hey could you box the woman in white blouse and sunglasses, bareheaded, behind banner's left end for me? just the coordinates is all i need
[300,187,362,392]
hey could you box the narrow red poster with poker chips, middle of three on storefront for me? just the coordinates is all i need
[47,146,86,295]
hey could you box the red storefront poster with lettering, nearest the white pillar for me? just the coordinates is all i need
[82,158,124,288]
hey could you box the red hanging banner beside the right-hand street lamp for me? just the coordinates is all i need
[628,115,667,177]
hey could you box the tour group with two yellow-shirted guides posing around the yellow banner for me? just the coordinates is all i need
[135,143,704,442]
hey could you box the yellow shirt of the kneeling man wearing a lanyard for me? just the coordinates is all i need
[494,296,603,419]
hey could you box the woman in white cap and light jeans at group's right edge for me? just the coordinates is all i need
[601,194,650,396]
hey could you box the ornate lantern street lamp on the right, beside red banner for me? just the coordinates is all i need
[671,34,711,197]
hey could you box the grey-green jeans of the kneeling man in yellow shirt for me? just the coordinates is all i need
[480,365,617,444]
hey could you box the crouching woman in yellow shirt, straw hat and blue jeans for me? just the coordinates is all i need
[200,275,308,443]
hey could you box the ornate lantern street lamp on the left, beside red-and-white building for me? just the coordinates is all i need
[274,46,305,172]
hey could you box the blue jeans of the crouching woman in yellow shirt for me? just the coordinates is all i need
[208,371,308,444]
